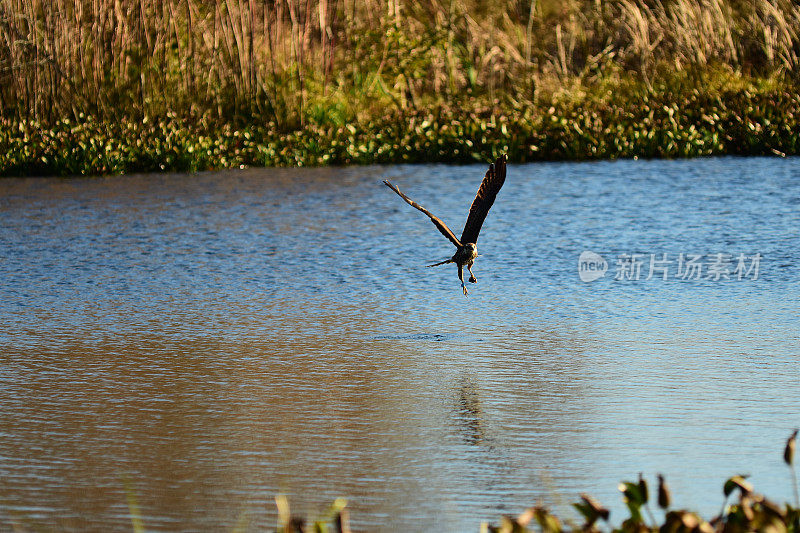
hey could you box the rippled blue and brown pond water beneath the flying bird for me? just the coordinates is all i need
[0,158,800,531]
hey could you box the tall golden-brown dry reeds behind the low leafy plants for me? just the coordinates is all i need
[0,0,800,127]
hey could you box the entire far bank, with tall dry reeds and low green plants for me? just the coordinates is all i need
[0,0,800,175]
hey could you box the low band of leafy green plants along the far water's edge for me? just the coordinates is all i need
[0,77,800,175]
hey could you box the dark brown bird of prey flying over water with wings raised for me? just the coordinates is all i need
[383,155,506,296]
